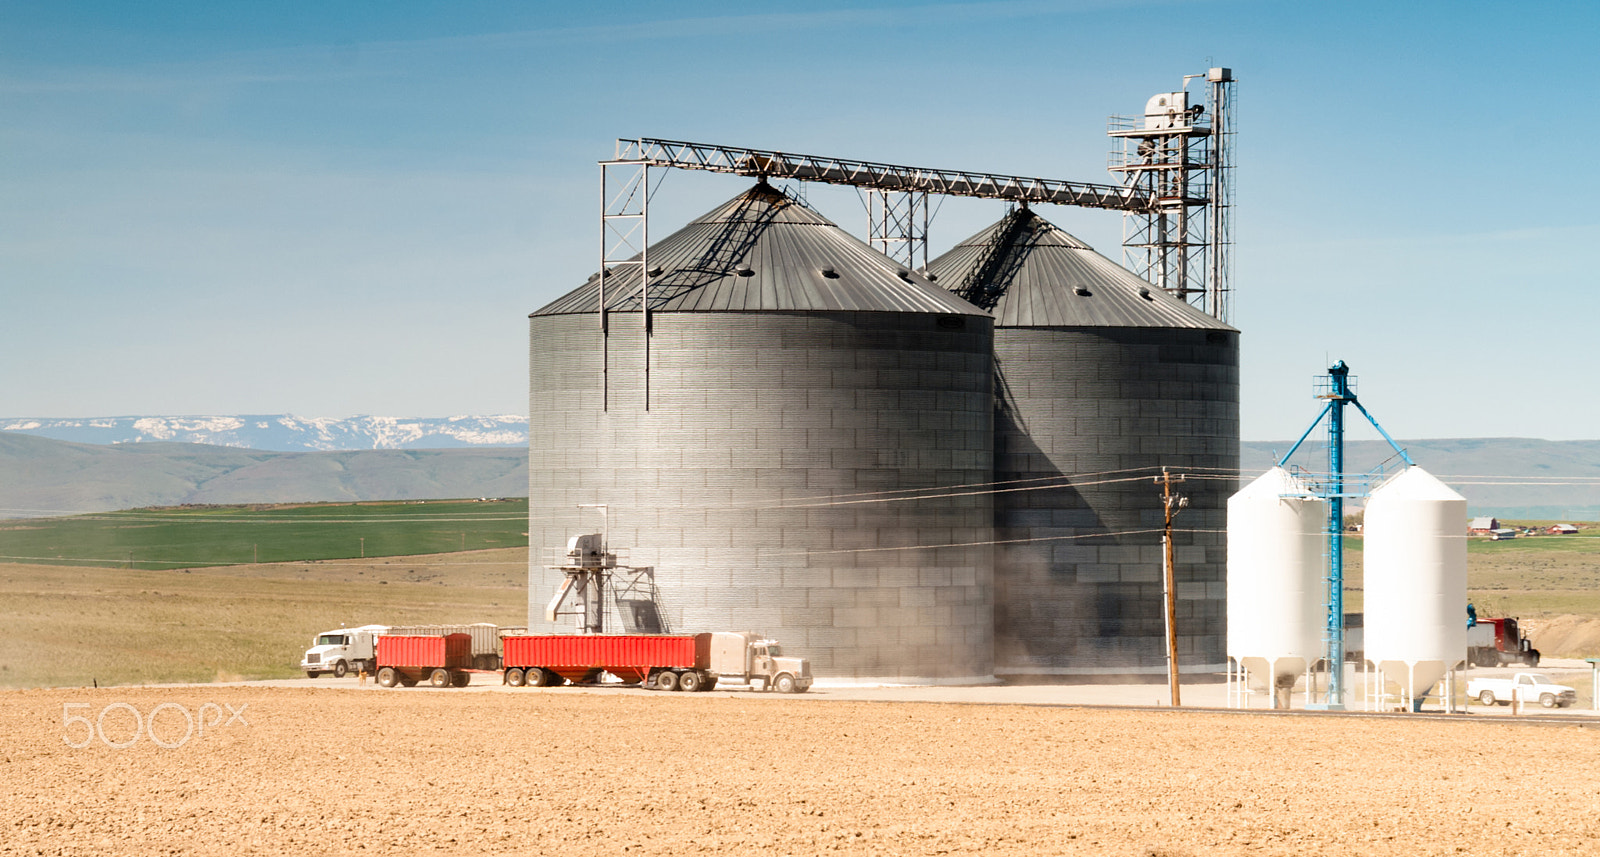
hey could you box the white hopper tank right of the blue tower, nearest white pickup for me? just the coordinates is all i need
[1362,467,1467,700]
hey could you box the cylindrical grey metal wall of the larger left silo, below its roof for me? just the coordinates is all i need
[528,312,994,680]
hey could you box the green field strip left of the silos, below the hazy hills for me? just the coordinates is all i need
[0,499,528,571]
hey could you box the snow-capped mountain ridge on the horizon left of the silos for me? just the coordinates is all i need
[0,414,528,452]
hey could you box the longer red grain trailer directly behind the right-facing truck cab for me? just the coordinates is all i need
[502,633,717,691]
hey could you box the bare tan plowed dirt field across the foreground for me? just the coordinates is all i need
[0,686,1600,857]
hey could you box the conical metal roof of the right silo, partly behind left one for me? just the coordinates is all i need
[928,208,1234,331]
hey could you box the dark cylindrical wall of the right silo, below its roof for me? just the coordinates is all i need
[995,328,1238,675]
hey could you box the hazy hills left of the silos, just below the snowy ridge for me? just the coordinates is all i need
[0,432,528,518]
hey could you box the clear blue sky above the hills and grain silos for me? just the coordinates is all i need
[0,0,1600,440]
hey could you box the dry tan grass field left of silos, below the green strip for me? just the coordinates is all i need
[0,548,528,688]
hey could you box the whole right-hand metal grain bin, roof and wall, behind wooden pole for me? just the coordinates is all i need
[928,208,1238,675]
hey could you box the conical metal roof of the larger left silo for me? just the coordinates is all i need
[533,182,987,317]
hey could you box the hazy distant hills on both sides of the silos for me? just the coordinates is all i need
[0,432,1600,521]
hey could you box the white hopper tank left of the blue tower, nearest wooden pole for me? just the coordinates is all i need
[1227,467,1328,708]
